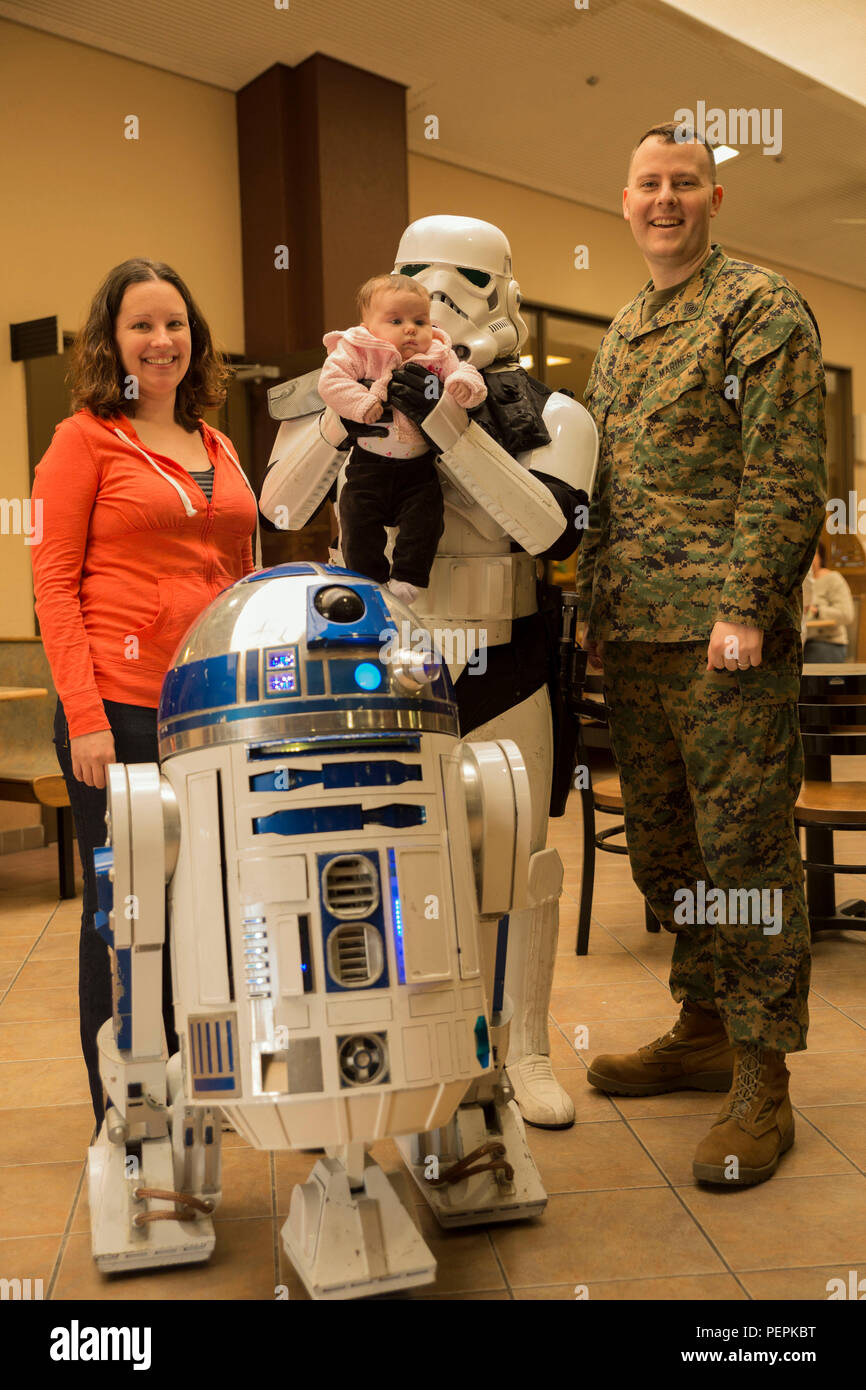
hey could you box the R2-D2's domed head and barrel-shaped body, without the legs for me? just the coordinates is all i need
[158,564,491,1150]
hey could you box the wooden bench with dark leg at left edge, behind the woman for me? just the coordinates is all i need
[0,637,75,898]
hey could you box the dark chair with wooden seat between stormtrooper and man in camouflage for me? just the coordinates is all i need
[574,676,662,955]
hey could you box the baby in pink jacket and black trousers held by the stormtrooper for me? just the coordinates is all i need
[318,275,487,603]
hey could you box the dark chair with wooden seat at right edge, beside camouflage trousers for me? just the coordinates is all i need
[794,664,866,937]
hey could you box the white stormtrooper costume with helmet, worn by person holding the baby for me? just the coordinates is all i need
[260,215,598,1129]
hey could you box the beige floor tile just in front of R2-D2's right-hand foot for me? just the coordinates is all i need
[491,1187,723,1289]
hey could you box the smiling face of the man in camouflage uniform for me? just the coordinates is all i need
[623,135,723,285]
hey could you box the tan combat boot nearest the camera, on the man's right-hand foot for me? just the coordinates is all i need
[692,1043,794,1187]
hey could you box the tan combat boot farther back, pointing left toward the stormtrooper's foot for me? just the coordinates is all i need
[587,999,734,1095]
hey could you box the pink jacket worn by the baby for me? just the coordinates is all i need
[318,324,487,443]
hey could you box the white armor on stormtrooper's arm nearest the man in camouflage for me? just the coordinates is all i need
[424,392,598,555]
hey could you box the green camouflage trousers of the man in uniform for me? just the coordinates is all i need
[605,631,812,1052]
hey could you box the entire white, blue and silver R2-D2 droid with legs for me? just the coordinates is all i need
[89,564,546,1298]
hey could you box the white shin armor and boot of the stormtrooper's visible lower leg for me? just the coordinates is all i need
[507,849,574,1129]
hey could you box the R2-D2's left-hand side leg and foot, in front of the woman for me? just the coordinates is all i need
[88,763,221,1273]
